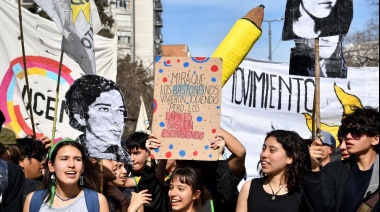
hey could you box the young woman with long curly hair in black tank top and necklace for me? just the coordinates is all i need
[236,130,308,212]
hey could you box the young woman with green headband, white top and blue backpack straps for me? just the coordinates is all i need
[24,139,108,212]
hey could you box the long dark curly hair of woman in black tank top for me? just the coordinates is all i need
[257,130,310,193]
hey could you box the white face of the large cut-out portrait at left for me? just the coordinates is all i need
[86,90,125,141]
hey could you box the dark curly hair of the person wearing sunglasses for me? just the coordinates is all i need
[338,106,379,152]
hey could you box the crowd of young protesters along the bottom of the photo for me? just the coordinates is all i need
[0,104,379,212]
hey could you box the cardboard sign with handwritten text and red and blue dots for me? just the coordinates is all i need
[152,57,222,161]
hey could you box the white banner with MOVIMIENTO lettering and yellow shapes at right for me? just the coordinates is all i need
[222,60,379,181]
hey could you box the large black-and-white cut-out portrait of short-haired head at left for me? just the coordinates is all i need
[65,75,131,163]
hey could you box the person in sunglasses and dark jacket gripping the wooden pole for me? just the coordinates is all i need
[304,107,379,212]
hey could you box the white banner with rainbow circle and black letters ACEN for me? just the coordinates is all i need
[0,0,117,139]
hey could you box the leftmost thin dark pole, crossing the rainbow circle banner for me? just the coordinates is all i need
[18,0,36,139]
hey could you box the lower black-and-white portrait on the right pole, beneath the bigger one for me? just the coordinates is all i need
[289,35,347,78]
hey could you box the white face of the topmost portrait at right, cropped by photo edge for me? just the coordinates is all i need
[302,0,337,18]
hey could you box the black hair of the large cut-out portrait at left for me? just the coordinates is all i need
[65,75,128,132]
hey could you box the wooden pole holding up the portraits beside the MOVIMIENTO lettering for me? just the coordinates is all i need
[312,38,321,141]
